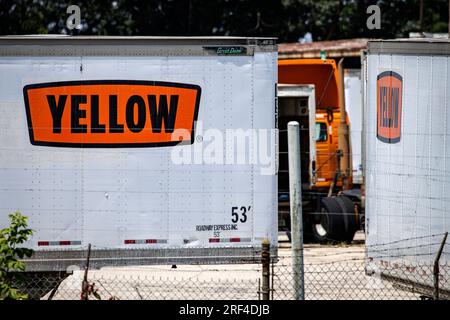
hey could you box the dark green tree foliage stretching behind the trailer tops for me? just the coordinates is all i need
[0,0,448,42]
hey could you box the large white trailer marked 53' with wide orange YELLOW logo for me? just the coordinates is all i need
[0,36,278,271]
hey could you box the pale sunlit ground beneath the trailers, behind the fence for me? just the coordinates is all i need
[45,233,426,300]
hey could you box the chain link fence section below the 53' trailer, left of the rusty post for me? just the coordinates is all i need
[22,265,261,300]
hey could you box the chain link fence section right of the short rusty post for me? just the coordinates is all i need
[272,257,450,300]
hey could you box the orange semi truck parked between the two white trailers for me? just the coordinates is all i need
[278,59,363,242]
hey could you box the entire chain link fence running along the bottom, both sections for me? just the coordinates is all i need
[10,232,450,300]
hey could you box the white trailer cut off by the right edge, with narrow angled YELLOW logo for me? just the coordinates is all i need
[363,39,450,296]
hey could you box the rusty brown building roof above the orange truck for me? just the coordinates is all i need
[278,38,369,59]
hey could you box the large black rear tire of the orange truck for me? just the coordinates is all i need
[311,197,357,243]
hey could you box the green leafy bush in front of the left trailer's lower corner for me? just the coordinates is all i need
[0,211,33,300]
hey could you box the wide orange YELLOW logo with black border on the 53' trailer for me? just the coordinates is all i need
[23,80,201,148]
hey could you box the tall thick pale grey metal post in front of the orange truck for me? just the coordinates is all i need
[288,121,305,300]
